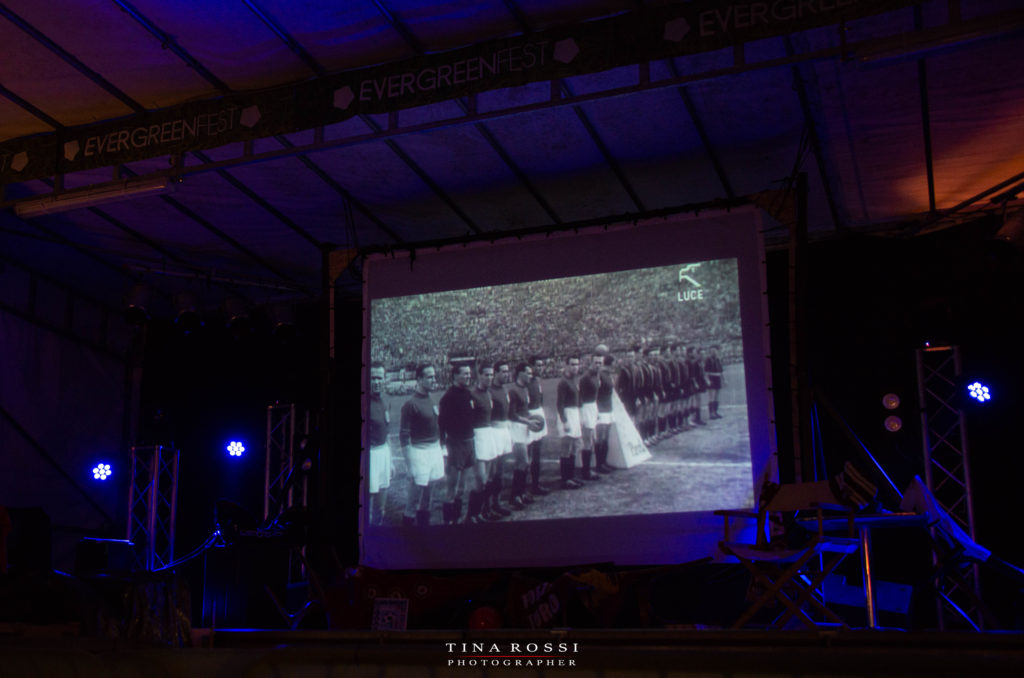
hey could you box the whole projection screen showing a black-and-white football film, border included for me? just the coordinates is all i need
[359,208,775,568]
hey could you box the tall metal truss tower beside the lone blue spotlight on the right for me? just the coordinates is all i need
[916,346,984,630]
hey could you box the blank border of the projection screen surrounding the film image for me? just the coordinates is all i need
[359,208,775,569]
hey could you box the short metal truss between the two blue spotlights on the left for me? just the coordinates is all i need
[128,444,179,571]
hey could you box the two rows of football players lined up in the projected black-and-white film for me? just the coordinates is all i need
[368,344,725,525]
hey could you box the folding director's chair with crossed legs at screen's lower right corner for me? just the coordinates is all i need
[716,480,860,629]
